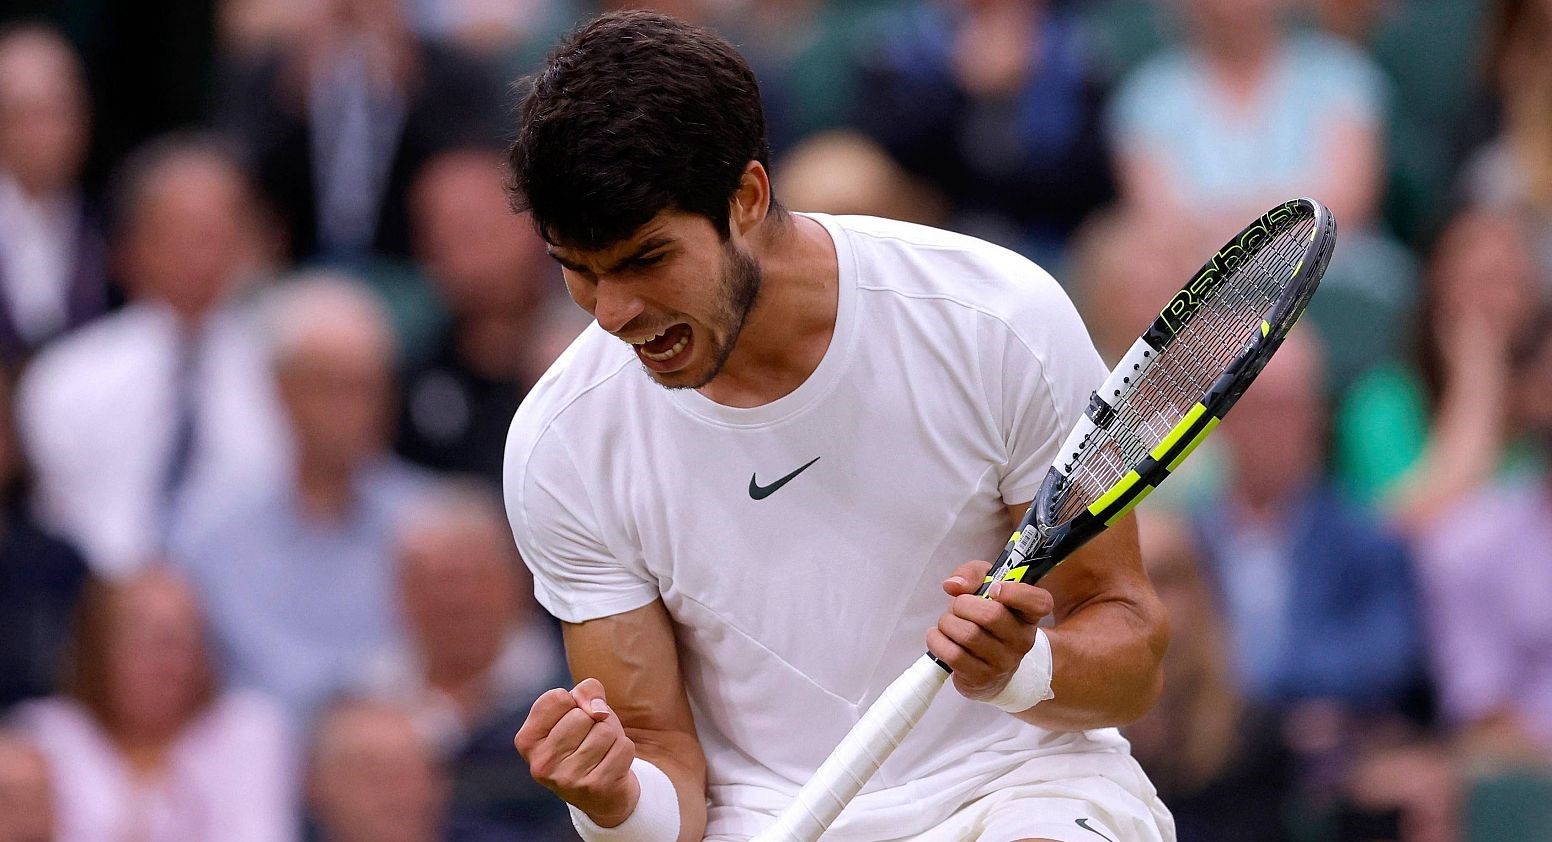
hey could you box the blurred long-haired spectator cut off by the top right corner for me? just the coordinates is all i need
[1464,0,1552,290]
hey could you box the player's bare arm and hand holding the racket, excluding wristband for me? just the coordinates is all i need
[928,506,1169,730]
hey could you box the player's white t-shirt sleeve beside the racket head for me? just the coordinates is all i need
[981,264,1110,506]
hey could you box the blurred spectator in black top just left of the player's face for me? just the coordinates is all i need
[397,149,563,487]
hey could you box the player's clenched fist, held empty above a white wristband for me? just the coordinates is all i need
[512,678,641,828]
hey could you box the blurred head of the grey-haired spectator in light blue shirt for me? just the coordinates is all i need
[276,296,393,473]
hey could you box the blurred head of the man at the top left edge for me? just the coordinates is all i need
[0,28,88,195]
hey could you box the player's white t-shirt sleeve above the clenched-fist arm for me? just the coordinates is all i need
[504,433,660,623]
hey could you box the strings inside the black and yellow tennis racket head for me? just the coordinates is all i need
[1054,217,1315,523]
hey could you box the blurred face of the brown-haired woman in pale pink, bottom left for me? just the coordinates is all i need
[104,572,210,738]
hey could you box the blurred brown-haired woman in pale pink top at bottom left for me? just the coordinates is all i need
[6,569,296,842]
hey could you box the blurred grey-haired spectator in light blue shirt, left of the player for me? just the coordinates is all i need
[175,276,424,726]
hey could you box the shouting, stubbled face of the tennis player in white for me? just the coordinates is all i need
[549,211,760,389]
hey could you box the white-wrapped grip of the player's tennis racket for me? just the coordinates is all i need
[751,654,948,842]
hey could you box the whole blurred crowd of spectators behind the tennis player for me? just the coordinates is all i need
[0,0,1552,842]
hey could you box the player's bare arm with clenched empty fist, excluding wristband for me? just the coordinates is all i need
[517,600,706,842]
